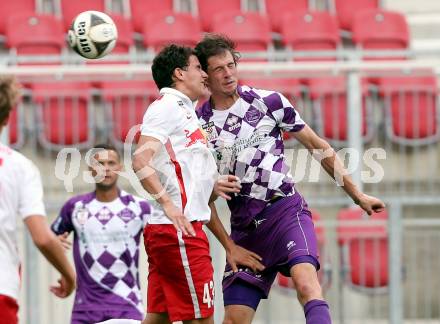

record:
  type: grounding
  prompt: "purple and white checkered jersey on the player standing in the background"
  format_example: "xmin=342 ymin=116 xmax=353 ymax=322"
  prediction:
xmin=52 ymin=191 xmax=151 ymax=320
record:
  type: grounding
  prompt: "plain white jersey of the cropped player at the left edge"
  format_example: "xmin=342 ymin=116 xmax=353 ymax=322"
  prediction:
xmin=0 ymin=143 xmax=46 ymax=299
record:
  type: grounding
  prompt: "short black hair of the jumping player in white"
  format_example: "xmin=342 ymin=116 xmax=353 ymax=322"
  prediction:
xmin=151 ymin=44 xmax=195 ymax=90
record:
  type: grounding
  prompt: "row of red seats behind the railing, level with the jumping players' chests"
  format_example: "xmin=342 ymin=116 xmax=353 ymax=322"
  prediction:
xmin=10 ymin=77 xmax=440 ymax=150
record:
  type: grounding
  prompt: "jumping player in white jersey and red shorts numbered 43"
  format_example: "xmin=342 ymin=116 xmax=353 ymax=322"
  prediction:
xmin=133 ymin=45 xmax=262 ymax=324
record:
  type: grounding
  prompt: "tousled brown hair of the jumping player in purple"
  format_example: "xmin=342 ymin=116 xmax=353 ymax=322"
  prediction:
xmin=195 ymin=33 xmax=240 ymax=72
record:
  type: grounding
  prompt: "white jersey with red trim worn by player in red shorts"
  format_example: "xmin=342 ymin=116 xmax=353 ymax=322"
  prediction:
xmin=141 ymin=88 xmax=217 ymax=224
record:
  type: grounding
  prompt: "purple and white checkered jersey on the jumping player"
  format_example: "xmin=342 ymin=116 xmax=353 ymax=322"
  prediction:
xmin=197 ymin=86 xmax=305 ymax=227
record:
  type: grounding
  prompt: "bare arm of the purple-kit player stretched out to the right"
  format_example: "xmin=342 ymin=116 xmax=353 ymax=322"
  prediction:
xmin=293 ymin=125 xmax=385 ymax=215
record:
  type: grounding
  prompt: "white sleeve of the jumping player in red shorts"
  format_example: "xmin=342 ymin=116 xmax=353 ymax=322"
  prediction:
xmin=141 ymin=99 xmax=178 ymax=144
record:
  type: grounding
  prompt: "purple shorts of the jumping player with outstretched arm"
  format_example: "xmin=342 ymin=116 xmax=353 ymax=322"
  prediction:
xmin=223 ymin=193 xmax=320 ymax=308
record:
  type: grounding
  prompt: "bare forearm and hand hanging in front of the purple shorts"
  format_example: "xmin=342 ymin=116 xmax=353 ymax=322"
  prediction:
xmin=206 ymin=202 xmax=264 ymax=272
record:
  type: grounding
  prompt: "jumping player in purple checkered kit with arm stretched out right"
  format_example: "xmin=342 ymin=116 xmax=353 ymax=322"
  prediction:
xmin=195 ymin=34 xmax=385 ymax=324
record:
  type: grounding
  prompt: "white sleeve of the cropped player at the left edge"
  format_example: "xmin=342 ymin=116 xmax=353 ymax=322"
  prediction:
xmin=18 ymin=159 xmax=46 ymax=219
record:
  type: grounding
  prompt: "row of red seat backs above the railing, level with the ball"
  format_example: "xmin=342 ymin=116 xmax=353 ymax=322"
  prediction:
xmin=0 ymin=1 xmax=409 ymax=63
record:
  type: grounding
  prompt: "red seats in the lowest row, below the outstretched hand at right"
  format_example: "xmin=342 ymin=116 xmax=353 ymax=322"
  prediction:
xmin=277 ymin=208 xmax=389 ymax=293
